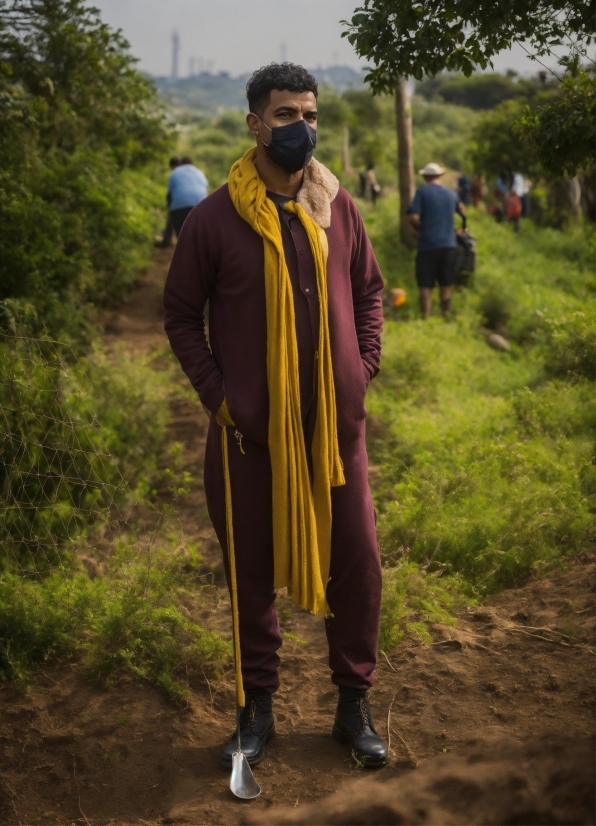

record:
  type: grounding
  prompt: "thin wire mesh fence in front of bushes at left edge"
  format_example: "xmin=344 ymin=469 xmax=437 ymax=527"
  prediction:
xmin=0 ymin=335 xmax=131 ymax=576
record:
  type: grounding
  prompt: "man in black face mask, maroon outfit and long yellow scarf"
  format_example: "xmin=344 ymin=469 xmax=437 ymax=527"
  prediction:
xmin=164 ymin=63 xmax=387 ymax=767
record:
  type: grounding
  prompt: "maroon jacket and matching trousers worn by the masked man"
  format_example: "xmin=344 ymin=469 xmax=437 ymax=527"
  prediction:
xmin=164 ymin=186 xmax=383 ymax=692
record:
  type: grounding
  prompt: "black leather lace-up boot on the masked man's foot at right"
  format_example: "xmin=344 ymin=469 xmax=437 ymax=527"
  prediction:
xmin=333 ymin=689 xmax=388 ymax=768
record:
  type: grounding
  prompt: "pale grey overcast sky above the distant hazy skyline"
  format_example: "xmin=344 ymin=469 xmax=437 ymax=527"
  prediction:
xmin=90 ymin=0 xmax=556 ymax=77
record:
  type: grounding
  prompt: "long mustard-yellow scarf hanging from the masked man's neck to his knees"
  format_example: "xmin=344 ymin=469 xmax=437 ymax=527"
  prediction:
xmin=226 ymin=148 xmax=345 ymax=616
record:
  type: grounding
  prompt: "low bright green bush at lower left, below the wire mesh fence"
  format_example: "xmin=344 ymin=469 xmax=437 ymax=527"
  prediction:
xmin=0 ymin=545 xmax=231 ymax=702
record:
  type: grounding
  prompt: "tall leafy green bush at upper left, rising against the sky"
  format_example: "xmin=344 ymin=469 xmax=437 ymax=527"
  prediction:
xmin=0 ymin=0 xmax=170 ymax=341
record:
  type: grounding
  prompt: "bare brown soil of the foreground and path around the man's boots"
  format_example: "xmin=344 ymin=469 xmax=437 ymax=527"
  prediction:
xmin=0 ymin=251 xmax=595 ymax=826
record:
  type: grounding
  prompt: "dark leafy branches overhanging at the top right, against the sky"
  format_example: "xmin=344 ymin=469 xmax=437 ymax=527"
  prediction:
xmin=342 ymin=0 xmax=594 ymax=93
